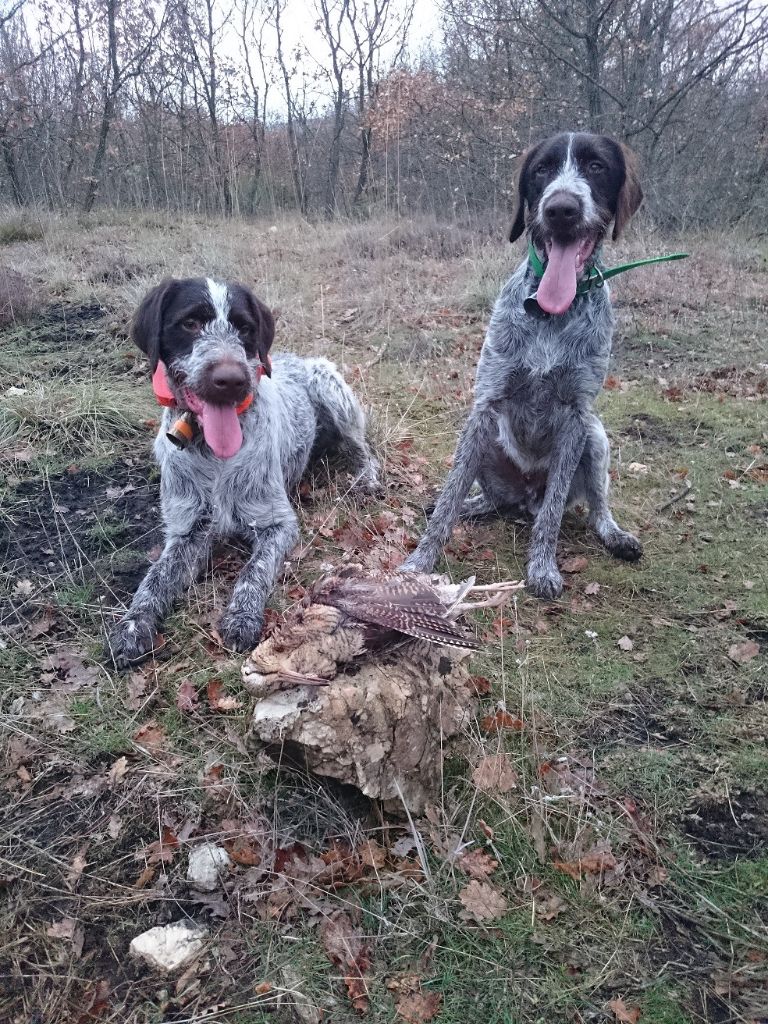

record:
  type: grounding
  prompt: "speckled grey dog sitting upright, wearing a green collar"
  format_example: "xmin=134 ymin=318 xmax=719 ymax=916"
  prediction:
xmin=402 ymin=133 xmax=642 ymax=598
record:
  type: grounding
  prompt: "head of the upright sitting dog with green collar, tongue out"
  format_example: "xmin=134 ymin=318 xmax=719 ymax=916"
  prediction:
xmin=510 ymin=132 xmax=643 ymax=313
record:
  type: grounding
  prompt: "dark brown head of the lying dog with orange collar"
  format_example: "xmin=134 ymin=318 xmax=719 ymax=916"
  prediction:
xmin=131 ymin=278 xmax=274 ymax=458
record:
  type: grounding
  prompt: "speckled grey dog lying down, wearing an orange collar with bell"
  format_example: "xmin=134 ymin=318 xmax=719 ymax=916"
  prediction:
xmin=109 ymin=279 xmax=378 ymax=666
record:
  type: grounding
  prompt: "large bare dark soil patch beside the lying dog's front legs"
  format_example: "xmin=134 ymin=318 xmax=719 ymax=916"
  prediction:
xmin=0 ymin=460 xmax=162 ymax=598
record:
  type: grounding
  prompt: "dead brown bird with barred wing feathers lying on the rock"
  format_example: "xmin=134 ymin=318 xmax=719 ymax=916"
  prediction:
xmin=243 ymin=565 xmax=523 ymax=692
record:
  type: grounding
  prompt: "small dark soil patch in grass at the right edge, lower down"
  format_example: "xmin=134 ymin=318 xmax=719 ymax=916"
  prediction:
xmin=685 ymin=791 xmax=768 ymax=860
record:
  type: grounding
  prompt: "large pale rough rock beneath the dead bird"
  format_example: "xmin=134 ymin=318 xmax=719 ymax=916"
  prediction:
xmin=243 ymin=640 xmax=476 ymax=814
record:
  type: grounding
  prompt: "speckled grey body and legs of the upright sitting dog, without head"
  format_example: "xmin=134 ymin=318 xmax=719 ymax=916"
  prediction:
xmin=402 ymin=260 xmax=642 ymax=597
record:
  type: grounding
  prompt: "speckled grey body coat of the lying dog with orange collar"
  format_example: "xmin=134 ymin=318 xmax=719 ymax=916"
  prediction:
xmin=109 ymin=352 xmax=378 ymax=665
